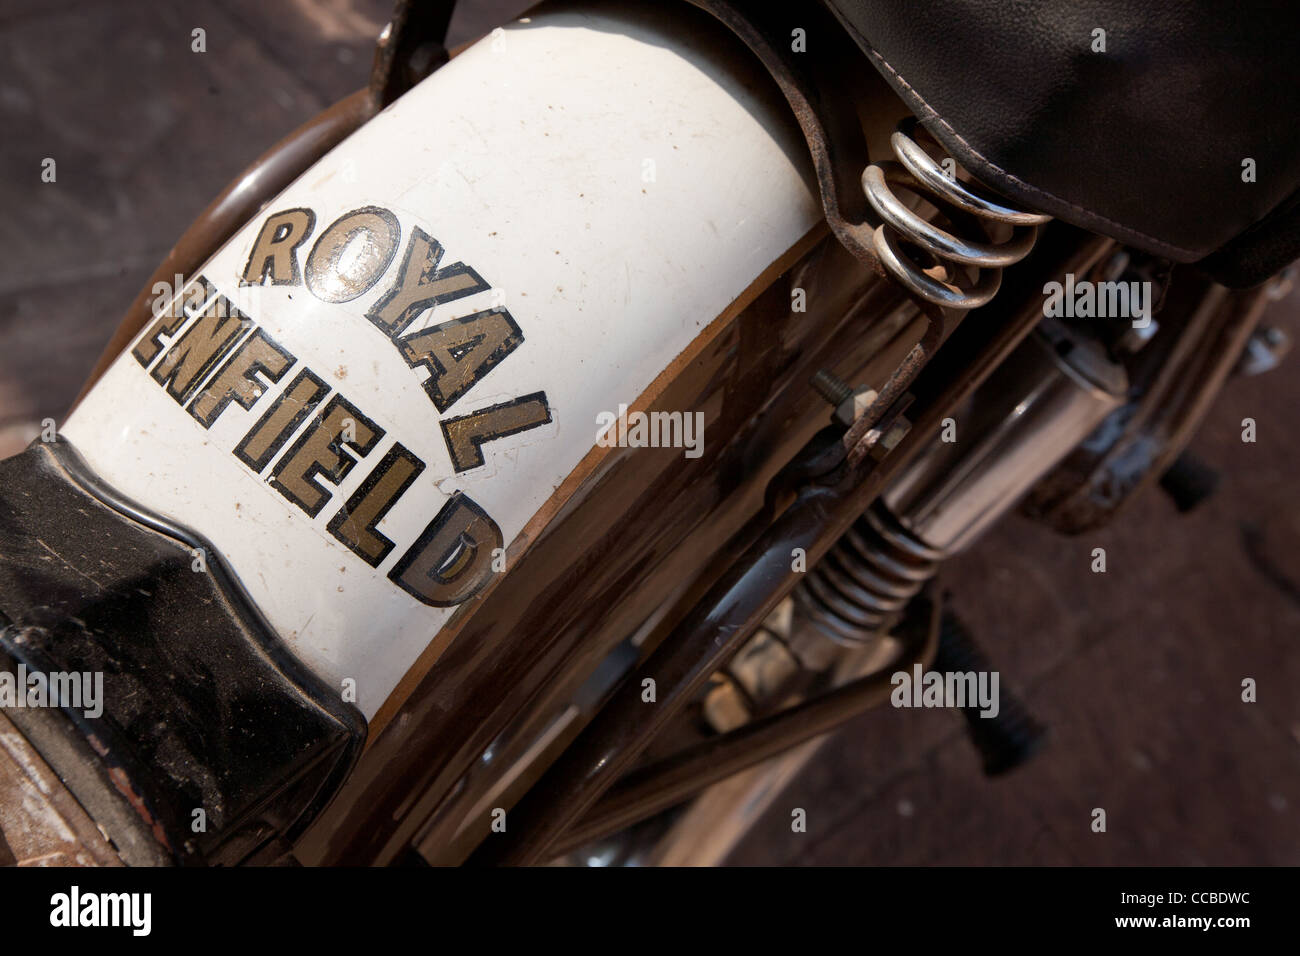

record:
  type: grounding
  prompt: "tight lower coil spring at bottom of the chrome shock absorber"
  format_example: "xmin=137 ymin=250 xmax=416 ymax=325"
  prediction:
xmin=794 ymin=502 xmax=945 ymax=644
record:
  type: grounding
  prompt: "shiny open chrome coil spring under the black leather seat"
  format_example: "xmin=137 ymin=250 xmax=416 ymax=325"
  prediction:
xmin=862 ymin=117 xmax=1052 ymax=310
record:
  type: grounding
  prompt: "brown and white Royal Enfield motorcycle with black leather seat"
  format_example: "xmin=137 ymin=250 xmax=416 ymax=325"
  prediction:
xmin=0 ymin=0 xmax=1300 ymax=865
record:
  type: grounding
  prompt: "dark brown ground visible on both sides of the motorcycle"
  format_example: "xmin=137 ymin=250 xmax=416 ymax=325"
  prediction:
xmin=0 ymin=0 xmax=1300 ymax=864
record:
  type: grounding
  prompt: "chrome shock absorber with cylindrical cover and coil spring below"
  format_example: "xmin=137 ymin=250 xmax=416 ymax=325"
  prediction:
xmin=794 ymin=319 xmax=1128 ymax=643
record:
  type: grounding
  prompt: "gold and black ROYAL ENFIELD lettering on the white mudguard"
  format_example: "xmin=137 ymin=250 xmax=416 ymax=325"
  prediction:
xmin=131 ymin=206 xmax=551 ymax=607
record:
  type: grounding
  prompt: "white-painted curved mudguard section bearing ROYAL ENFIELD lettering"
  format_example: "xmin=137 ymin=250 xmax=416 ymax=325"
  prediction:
xmin=62 ymin=4 xmax=820 ymax=718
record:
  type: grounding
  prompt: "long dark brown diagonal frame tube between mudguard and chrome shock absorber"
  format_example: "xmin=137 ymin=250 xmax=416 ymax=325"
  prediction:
xmin=476 ymin=229 xmax=1113 ymax=865
